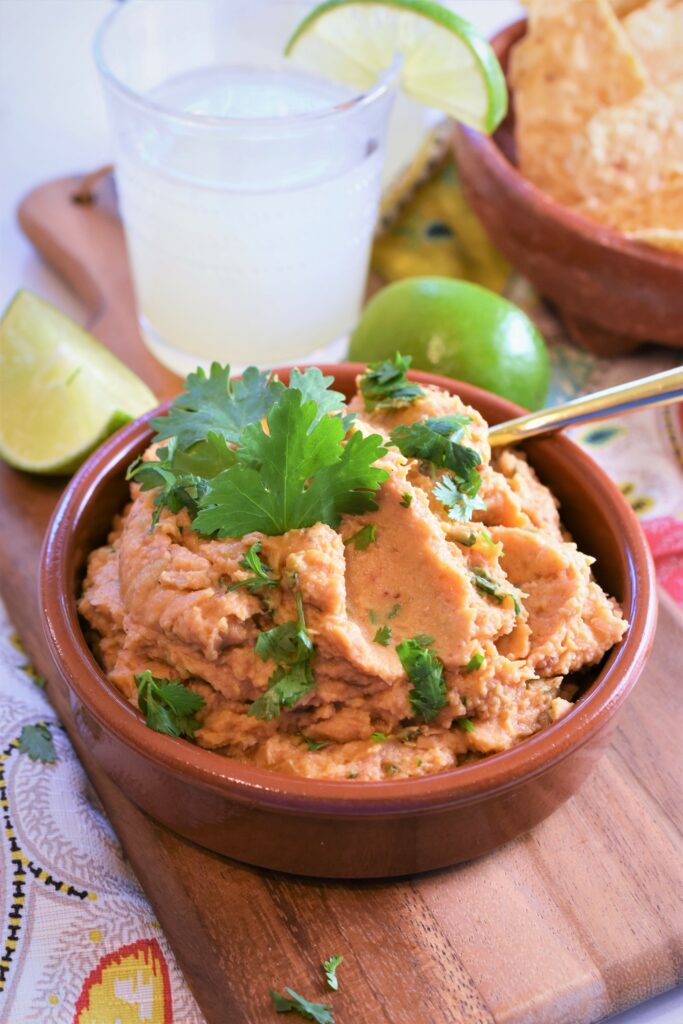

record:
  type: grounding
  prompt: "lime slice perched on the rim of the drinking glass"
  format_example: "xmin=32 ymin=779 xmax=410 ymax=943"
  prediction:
xmin=285 ymin=0 xmax=508 ymax=133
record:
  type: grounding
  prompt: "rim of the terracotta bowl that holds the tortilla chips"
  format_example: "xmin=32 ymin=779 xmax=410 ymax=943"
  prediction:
xmin=455 ymin=17 xmax=683 ymax=273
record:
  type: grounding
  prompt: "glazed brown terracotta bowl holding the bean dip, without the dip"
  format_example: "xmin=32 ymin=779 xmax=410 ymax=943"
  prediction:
xmin=41 ymin=364 xmax=656 ymax=878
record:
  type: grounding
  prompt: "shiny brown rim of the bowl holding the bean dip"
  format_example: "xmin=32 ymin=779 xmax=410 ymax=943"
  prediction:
xmin=40 ymin=364 xmax=656 ymax=816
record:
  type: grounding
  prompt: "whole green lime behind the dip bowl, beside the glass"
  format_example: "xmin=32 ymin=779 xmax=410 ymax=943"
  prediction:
xmin=348 ymin=278 xmax=550 ymax=409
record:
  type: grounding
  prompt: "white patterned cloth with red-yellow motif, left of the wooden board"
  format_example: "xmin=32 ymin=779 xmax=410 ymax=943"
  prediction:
xmin=0 ymin=603 xmax=204 ymax=1024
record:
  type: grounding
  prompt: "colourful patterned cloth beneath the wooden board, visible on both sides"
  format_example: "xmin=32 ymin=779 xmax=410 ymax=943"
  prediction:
xmin=0 ymin=146 xmax=683 ymax=1024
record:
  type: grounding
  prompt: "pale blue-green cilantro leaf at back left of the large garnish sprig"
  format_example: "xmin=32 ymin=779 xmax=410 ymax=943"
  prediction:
xmin=151 ymin=362 xmax=278 ymax=451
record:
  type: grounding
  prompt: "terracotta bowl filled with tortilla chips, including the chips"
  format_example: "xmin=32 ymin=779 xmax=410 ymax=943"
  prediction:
xmin=455 ymin=12 xmax=683 ymax=355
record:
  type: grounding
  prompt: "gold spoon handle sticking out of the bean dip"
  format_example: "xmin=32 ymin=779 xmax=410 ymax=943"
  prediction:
xmin=488 ymin=367 xmax=683 ymax=446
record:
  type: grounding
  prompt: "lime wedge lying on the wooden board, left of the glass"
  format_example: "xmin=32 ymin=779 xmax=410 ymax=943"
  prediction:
xmin=0 ymin=292 xmax=157 ymax=473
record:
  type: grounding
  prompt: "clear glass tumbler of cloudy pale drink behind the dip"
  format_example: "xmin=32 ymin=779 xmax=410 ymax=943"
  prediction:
xmin=95 ymin=0 xmax=395 ymax=374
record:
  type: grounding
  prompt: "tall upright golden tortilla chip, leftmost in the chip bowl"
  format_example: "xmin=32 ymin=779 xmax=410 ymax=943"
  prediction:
xmin=510 ymin=0 xmax=646 ymax=203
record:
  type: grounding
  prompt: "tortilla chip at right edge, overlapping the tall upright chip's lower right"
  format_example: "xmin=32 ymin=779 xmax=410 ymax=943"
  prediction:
xmin=568 ymin=79 xmax=683 ymax=209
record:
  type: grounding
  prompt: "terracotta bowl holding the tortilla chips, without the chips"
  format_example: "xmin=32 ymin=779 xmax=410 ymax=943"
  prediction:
xmin=454 ymin=19 xmax=683 ymax=355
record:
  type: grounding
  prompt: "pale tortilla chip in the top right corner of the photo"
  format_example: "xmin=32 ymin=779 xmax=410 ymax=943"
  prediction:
xmin=623 ymin=0 xmax=683 ymax=85
